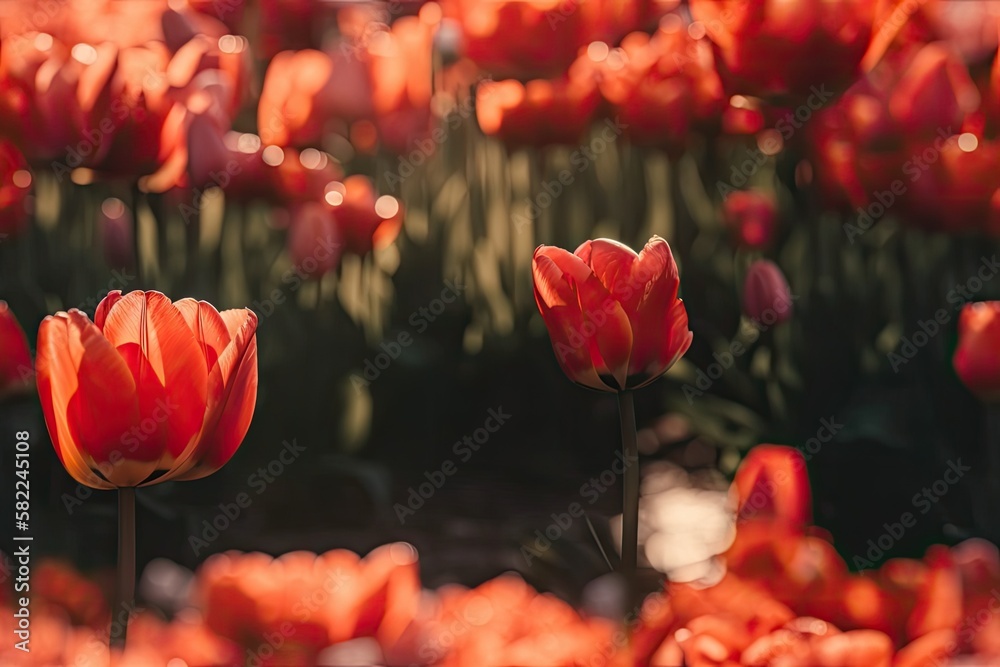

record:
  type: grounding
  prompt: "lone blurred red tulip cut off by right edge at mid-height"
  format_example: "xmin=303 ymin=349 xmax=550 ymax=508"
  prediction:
xmin=952 ymin=301 xmax=1000 ymax=403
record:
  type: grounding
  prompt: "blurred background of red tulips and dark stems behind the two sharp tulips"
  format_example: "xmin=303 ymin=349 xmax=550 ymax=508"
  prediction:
xmin=0 ymin=0 xmax=1000 ymax=616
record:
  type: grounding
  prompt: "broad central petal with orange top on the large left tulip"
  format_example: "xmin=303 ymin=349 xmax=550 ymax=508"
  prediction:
xmin=104 ymin=291 xmax=208 ymax=468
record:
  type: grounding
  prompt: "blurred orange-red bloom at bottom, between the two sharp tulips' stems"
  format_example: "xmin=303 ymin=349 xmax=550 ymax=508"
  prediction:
xmin=196 ymin=543 xmax=425 ymax=667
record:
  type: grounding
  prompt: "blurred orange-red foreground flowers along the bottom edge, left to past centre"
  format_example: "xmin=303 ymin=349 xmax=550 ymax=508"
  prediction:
xmin=0 ymin=544 xmax=628 ymax=667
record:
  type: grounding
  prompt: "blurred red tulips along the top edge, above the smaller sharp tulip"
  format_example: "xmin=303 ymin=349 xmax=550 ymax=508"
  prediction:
xmin=468 ymin=0 xmax=875 ymax=150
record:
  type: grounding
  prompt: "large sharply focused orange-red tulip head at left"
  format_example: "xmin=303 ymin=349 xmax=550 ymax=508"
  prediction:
xmin=37 ymin=291 xmax=257 ymax=489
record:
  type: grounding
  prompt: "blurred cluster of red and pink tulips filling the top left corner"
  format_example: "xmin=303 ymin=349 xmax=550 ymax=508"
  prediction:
xmin=0 ymin=0 xmax=410 ymax=275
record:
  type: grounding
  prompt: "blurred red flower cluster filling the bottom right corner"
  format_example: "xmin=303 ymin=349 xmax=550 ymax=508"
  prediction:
xmin=635 ymin=445 xmax=1000 ymax=667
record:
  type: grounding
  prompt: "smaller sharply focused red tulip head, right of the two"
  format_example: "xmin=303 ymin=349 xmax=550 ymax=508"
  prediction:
xmin=532 ymin=236 xmax=692 ymax=392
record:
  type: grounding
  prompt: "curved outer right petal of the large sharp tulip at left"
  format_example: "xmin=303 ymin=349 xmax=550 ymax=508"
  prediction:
xmin=168 ymin=309 xmax=257 ymax=480
